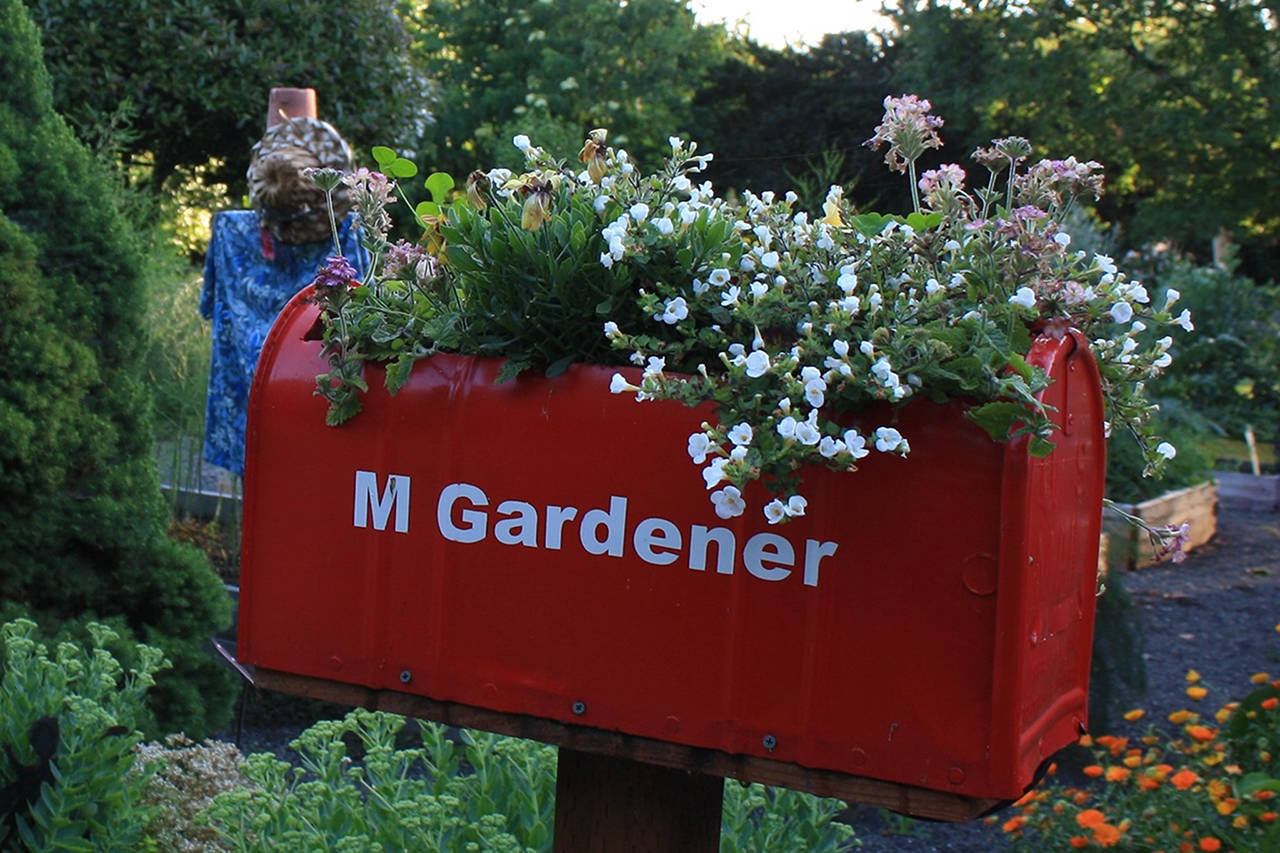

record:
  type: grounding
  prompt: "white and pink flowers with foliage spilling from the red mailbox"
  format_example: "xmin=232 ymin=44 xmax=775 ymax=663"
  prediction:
xmin=307 ymin=95 xmax=1192 ymax=523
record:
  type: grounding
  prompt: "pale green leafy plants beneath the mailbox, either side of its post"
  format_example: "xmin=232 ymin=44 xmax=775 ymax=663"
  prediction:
xmin=205 ymin=710 xmax=856 ymax=853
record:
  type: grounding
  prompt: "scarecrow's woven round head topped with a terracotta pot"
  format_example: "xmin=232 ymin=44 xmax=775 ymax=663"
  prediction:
xmin=248 ymin=88 xmax=356 ymax=246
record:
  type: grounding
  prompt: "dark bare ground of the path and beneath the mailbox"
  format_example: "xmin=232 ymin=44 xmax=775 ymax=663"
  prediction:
xmin=209 ymin=506 xmax=1280 ymax=853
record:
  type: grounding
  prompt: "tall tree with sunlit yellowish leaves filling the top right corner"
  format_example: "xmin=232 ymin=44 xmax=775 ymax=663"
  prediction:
xmin=893 ymin=0 xmax=1280 ymax=274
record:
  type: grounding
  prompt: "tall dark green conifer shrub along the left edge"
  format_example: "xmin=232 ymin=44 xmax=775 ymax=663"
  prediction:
xmin=0 ymin=0 xmax=234 ymax=734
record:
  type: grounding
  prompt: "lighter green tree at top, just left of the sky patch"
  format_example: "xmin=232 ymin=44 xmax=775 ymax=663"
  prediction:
xmin=412 ymin=0 xmax=724 ymax=177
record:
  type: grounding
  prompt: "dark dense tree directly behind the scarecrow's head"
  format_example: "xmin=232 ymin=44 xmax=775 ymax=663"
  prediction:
xmin=27 ymin=0 xmax=435 ymax=197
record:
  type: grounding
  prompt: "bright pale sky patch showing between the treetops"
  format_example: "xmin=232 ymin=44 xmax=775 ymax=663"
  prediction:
xmin=689 ymin=0 xmax=884 ymax=47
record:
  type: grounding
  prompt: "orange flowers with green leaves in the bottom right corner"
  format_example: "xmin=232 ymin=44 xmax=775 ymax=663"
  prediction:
xmin=988 ymin=670 xmax=1280 ymax=853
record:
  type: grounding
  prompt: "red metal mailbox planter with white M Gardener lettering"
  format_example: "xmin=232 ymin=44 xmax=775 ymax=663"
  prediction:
xmin=238 ymin=284 xmax=1105 ymax=811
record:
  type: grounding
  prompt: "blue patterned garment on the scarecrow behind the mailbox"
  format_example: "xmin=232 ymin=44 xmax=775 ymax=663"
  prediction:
xmin=200 ymin=210 xmax=367 ymax=476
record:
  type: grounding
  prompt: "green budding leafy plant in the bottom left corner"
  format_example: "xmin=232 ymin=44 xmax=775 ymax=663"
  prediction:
xmin=0 ymin=620 xmax=165 ymax=852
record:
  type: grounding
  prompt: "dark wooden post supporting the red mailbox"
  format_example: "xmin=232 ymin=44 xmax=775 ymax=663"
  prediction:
xmin=553 ymin=747 xmax=724 ymax=853
